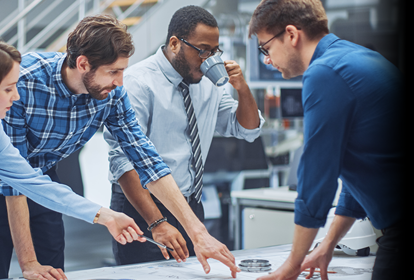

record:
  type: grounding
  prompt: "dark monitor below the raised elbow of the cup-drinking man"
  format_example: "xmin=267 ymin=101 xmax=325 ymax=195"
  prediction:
xmin=204 ymin=136 xmax=268 ymax=173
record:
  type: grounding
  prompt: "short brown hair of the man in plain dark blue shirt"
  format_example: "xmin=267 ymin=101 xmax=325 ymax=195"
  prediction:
xmin=249 ymin=0 xmax=329 ymax=40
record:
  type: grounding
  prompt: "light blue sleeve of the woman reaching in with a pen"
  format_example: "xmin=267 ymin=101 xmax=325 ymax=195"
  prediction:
xmin=0 ymin=122 xmax=101 ymax=223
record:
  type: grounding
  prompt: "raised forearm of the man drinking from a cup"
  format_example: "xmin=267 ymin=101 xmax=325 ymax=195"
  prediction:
xmin=236 ymin=84 xmax=260 ymax=129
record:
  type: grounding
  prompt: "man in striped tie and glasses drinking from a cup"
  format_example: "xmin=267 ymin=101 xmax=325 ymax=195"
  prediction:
xmin=104 ymin=6 xmax=264 ymax=264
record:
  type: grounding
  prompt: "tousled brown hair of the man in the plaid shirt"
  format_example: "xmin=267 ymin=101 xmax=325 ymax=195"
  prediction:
xmin=66 ymin=15 xmax=135 ymax=69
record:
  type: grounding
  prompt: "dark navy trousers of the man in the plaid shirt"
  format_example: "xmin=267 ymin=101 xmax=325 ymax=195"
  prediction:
xmin=0 ymin=169 xmax=65 ymax=279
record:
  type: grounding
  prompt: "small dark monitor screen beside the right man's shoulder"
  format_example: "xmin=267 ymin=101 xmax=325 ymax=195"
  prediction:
xmin=280 ymin=88 xmax=303 ymax=119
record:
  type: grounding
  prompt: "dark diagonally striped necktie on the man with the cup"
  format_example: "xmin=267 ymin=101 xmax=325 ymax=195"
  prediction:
xmin=179 ymin=81 xmax=204 ymax=202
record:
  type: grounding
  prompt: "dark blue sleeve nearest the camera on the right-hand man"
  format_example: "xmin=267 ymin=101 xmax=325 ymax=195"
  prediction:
xmin=295 ymin=64 xmax=356 ymax=228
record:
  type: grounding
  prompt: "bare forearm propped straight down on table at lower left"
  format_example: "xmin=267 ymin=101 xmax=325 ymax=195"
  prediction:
xmin=6 ymin=195 xmax=37 ymax=270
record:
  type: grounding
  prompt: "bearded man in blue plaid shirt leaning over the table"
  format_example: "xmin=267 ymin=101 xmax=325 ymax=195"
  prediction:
xmin=0 ymin=16 xmax=239 ymax=279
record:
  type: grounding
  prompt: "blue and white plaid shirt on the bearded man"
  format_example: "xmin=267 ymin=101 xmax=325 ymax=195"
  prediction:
xmin=0 ymin=53 xmax=170 ymax=195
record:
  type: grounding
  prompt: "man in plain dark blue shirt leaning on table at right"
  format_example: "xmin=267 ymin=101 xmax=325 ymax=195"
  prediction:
xmin=249 ymin=0 xmax=404 ymax=279
